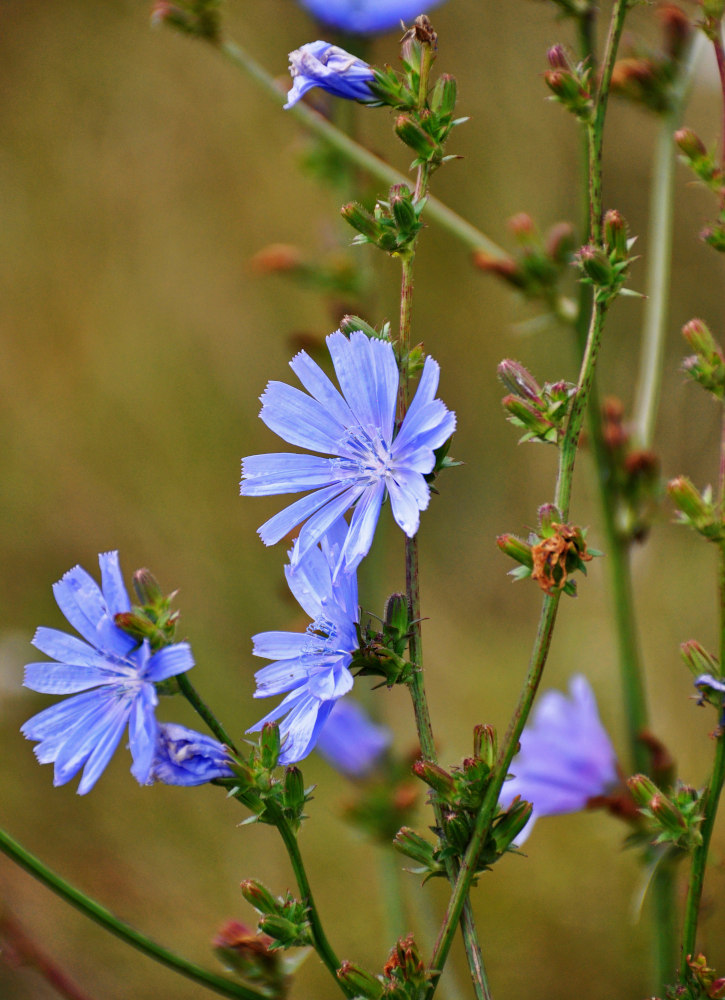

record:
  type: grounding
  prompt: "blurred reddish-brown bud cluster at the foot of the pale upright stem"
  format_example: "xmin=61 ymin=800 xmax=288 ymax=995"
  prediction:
xmin=602 ymin=397 xmax=662 ymax=542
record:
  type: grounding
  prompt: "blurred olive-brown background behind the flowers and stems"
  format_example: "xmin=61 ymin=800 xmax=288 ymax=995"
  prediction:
xmin=0 ymin=0 xmax=725 ymax=1000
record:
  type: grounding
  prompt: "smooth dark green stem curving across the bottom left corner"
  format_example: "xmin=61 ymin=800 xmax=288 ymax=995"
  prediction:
xmin=0 ymin=830 xmax=263 ymax=1000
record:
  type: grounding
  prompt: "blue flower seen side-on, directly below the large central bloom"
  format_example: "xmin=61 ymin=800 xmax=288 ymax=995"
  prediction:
xmin=249 ymin=521 xmax=359 ymax=764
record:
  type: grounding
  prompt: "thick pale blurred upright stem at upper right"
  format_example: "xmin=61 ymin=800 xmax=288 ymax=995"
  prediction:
xmin=633 ymin=32 xmax=706 ymax=449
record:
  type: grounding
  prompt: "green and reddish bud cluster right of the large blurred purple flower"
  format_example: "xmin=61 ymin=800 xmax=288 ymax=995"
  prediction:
xmin=627 ymin=774 xmax=704 ymax=852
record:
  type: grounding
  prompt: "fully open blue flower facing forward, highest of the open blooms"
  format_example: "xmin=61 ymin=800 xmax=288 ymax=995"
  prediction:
xmin=241 ymin=330 xmax=456 ymax=572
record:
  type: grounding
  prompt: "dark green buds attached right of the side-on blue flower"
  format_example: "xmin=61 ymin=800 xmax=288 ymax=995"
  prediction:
xmin=350 ymin=594 xmax=413 ymax=687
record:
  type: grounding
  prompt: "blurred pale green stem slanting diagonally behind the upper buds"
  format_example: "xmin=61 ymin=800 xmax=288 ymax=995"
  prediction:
xmin=218 ymin=38 xmax=508 ymax=260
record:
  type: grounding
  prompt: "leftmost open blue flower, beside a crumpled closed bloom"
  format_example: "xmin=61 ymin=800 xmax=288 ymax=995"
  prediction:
xmin=21 ymin=552 xmax=194 ymax=795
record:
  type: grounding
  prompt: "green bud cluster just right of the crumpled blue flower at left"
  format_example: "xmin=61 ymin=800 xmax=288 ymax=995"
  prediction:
xmin=228 ymin=722 xmax=314 ymax=830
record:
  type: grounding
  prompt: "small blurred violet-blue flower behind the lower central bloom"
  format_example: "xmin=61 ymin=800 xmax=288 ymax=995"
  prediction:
xmin=317 ymin=698 xmax=393 ymax=778
